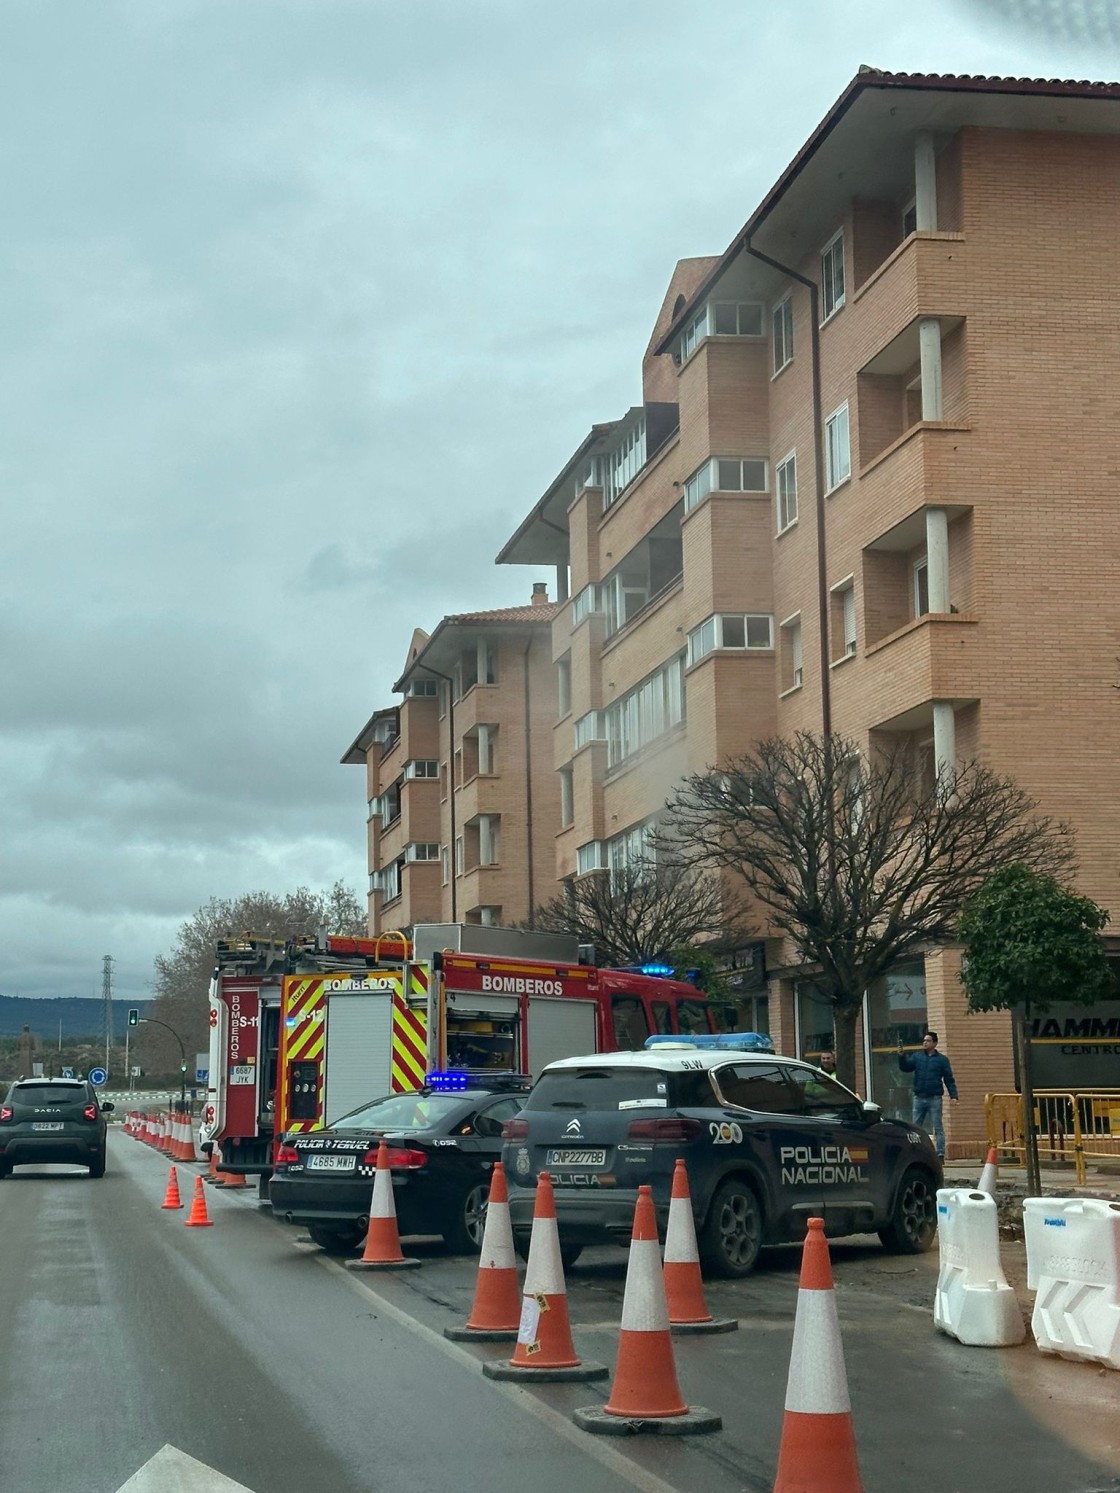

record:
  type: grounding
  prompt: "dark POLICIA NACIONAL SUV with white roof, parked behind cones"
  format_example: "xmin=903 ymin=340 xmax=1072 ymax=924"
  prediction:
xmin=503 ymin=1033 xmax=942 ymax=1277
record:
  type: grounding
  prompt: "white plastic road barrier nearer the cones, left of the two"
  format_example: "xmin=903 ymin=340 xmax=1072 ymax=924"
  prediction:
xmin=933 ymin=1187 xmax=1026 ymax=1348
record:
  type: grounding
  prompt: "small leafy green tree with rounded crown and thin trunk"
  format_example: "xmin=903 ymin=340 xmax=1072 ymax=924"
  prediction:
xmin=959 ymin=866 xmax=1113 ymax=1194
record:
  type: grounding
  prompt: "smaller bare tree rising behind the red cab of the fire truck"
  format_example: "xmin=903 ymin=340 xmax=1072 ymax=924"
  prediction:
xmin=533 ymin=860 xmax=747 ymax=966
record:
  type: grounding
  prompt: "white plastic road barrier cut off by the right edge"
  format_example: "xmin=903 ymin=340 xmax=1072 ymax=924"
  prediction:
xmin=1023 ymin=1197 xmax=1120 ymax=1369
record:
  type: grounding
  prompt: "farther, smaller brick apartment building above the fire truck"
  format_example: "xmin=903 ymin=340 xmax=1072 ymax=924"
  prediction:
xmin=342 ymin=584 xmax=560 ymax=935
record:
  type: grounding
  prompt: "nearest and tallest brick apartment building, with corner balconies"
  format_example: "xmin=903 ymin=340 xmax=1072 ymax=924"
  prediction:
xmin=499 ymin=70 xmax=1120 ymax=1154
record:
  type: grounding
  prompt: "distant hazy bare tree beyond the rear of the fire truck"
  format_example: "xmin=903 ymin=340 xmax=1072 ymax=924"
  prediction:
xmin=137 ymin=881 xmax=366 ymax=1072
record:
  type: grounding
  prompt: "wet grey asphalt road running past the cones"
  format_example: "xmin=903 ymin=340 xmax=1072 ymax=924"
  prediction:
xmin=0 ymin=1133 xmax=1120 ymax=1493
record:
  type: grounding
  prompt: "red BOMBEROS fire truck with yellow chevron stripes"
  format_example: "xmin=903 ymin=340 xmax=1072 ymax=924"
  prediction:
xmin=203 ymin=924 xmax=715 ymax=1176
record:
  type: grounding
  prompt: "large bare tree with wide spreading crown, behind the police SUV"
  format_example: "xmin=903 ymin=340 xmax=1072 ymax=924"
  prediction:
xmin=665 ymin=732 xmax=1072 ymax=1084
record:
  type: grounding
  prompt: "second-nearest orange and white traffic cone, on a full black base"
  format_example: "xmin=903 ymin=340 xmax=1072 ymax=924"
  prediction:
xmin=572 ymin=1185 xmax=723 ymax=1436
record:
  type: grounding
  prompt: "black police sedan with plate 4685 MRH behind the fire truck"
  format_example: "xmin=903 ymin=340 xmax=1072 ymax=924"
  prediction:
xmin=269 ymin=1073 xmax=530 ymax=1254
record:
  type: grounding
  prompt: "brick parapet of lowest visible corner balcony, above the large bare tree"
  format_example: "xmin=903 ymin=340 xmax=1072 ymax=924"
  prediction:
xmin=865 ymin=612 xmax=984 ymax=730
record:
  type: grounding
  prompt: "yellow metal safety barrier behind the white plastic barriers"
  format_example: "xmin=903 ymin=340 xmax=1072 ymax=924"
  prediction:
xmin=984 ymin=1088 xmax=1120 ymax=1185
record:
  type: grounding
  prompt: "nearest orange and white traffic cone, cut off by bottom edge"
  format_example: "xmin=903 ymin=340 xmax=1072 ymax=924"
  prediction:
xmin=774 ymin=1218 xmax=863 ymax=1493
